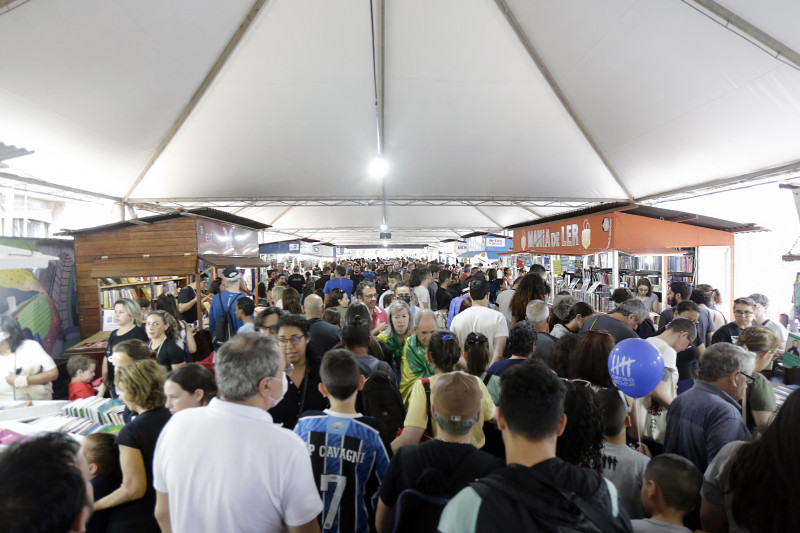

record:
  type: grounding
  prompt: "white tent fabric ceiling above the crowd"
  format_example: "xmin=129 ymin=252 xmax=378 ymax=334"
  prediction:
xmin=0 ymin=0 xmax=800 ymax=244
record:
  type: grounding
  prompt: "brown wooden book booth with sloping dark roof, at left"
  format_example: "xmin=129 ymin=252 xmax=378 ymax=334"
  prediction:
xmin=64 ymin=209 xmax=269 ymax=339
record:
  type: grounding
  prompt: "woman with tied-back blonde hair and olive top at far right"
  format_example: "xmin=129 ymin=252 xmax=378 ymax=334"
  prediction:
xmin=736 ymin=326 xmax=779 ymax=437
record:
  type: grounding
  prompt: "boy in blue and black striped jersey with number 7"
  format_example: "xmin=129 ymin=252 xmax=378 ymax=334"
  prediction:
xmin=294 ymin=349 xmax=390 ymax=533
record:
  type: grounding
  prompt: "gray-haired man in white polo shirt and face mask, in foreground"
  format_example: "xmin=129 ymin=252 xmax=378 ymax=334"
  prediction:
xmin=153 ymin=333 xmax=322 ymax=533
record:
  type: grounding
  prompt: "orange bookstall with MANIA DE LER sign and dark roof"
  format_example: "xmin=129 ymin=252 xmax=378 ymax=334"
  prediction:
xmin=508 ymin=204 xmax=759 ymax=312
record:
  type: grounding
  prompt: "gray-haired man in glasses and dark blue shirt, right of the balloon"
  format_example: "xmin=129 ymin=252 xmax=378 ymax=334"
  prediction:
xmin=664 ymin=342 xmax=755 ymax=472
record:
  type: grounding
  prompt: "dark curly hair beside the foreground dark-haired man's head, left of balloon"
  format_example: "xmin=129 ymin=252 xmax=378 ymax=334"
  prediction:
xmin=556 ymin=380 xmax=603 ymax=472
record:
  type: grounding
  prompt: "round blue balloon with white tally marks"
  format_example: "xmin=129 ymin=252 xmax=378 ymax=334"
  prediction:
xmin=608 ymin=339 xmax=664 ymax=398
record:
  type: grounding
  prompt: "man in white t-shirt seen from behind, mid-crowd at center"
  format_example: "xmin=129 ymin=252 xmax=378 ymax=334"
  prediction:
xmin=450 ymin=279 xmax=508 ymax=362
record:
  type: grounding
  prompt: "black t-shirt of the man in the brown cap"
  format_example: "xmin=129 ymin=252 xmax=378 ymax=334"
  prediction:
xmin=380 ymin=439 xmax=504 ymax=508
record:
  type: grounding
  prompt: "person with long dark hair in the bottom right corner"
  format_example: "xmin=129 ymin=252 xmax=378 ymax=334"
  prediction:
xmin=700 ymin=390 xmax=800 ymax=533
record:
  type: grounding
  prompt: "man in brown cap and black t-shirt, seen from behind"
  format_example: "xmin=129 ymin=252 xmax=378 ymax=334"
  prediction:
xmin=375 ymin=372 xmax=503 ymax=531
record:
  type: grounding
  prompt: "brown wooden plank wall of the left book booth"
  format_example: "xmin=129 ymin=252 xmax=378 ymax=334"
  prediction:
xmin=75 ymin=217 xmax=197 ymax=339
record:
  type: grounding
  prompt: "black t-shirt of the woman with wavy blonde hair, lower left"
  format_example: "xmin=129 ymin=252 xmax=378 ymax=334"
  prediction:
xmin=108 ymin=407 xmax=170 ymax=533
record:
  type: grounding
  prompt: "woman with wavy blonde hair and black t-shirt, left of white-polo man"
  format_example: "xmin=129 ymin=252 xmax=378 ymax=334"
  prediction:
xmin=94 ymin=358 xmax=170 ymax=533
